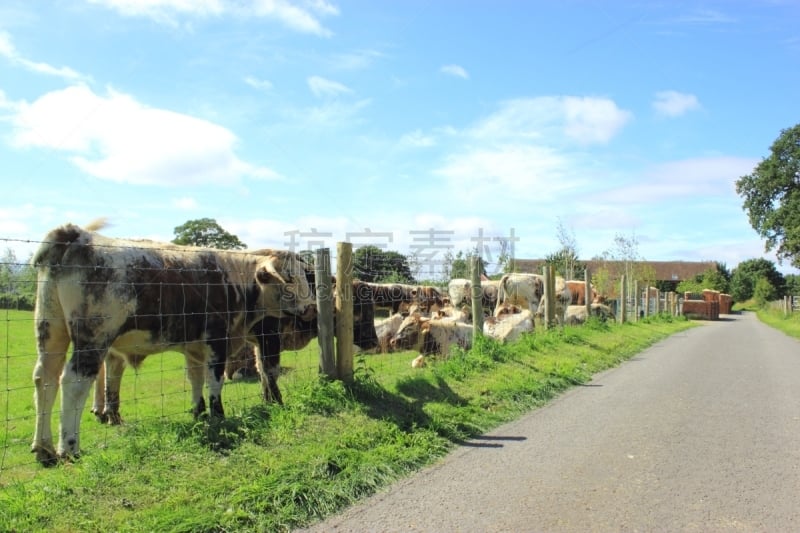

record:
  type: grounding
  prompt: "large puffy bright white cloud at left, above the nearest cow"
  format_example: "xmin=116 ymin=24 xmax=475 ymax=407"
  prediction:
xmin=7 ymin=85 xmax=277 ymax=185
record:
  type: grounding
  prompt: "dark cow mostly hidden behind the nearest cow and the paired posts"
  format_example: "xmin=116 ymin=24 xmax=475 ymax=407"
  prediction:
xmin=92 ymin=278 xmax=378 ymax=425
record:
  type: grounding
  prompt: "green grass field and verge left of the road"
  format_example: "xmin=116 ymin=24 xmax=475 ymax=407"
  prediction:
xmin=0 ymin=311 xmax=691 ymax=531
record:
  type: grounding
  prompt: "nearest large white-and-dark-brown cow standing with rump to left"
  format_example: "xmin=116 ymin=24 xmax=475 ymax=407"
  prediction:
xmin=31 ymin=223 xmax=316 ymax=466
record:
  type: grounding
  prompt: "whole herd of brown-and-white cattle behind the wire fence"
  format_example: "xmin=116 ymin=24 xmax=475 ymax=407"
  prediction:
xmin=26 ymin=222 xmax=610 ymax=465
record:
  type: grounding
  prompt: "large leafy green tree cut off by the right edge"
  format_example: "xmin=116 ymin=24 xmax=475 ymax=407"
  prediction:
xmin=736 ymin=124 xmax=800 ymax=267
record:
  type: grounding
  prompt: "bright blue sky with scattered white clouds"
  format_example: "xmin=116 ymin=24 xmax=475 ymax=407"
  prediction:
xmin=0 ymin=0 xmax=800 ymax=277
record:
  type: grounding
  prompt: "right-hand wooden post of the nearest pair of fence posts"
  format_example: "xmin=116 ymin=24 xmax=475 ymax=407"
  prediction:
xmin=336 ymin=242 xmax=353 ymax=381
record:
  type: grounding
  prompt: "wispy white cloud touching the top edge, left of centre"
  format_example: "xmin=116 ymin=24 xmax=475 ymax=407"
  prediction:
xmin=89 ymin=0 xmax=339 ymax=37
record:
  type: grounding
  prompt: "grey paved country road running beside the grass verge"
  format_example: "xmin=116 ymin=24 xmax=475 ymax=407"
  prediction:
xmin=298 ymin=314 xmax=800 ymax=532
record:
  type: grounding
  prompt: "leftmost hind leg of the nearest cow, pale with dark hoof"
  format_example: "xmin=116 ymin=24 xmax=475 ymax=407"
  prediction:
xmin=31 ymin=316 xmax=70 ymax=466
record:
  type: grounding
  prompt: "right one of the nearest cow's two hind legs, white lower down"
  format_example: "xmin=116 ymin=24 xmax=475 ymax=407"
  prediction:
xmin=57 ymin=339 xmax=108 ymax=458
